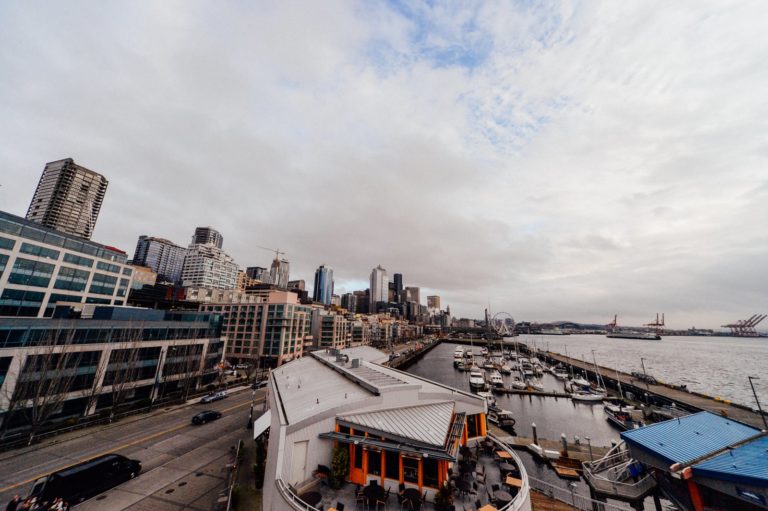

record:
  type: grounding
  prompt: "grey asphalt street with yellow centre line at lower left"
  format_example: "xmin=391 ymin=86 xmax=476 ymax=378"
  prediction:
xmin=0 ymin=389 xmax=264 ymax=511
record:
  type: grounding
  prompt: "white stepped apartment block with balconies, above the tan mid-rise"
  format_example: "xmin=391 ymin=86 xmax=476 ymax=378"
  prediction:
xmin=181 ymin=244 xmax=240 ymax=289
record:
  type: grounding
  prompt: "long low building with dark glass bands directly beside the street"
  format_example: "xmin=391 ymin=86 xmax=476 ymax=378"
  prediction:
xmin=0 ymin=304 xmax=224 ymax=431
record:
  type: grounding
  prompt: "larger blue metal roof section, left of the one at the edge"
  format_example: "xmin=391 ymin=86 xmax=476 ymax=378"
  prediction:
xmin=621 ymin=412 xmax=760 ymax=465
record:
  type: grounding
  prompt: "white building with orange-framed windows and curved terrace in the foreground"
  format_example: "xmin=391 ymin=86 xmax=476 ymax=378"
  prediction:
xmin=260 ymin=347 xmax=531 ymax=511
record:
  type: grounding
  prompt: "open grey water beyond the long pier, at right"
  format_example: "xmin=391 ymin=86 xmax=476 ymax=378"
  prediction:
xmin=515 ymin=335 xmax=768 ymax=408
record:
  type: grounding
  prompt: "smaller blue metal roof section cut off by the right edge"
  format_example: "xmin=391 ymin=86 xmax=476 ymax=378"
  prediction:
xmin=693 ymin=437 xmax=768 ymax=487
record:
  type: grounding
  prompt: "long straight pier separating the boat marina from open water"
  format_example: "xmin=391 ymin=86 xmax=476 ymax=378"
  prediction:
xmin=545 ymin=352 xmax=764 ymax=429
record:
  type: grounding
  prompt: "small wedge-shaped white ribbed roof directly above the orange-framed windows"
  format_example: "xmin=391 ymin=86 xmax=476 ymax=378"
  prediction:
xmin=339 ymin=401 xmax=454 ymax=447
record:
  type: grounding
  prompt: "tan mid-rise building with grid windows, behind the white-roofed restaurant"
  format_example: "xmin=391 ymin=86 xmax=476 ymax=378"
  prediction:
xmin=200 ymin=289 xmax=312 ymax=368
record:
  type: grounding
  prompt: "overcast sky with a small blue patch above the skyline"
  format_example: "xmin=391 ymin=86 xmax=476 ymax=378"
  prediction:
xmin=0 ymin=0 xmax=768 ymax=328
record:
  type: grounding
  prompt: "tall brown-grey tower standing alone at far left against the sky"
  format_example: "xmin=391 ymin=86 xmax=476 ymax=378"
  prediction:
xmin=27 ymin=158 xmax=109 ymax=240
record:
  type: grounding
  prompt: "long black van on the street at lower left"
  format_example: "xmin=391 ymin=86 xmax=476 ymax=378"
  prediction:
xmin=29 ymin=454 xmax=141 ymax=505
